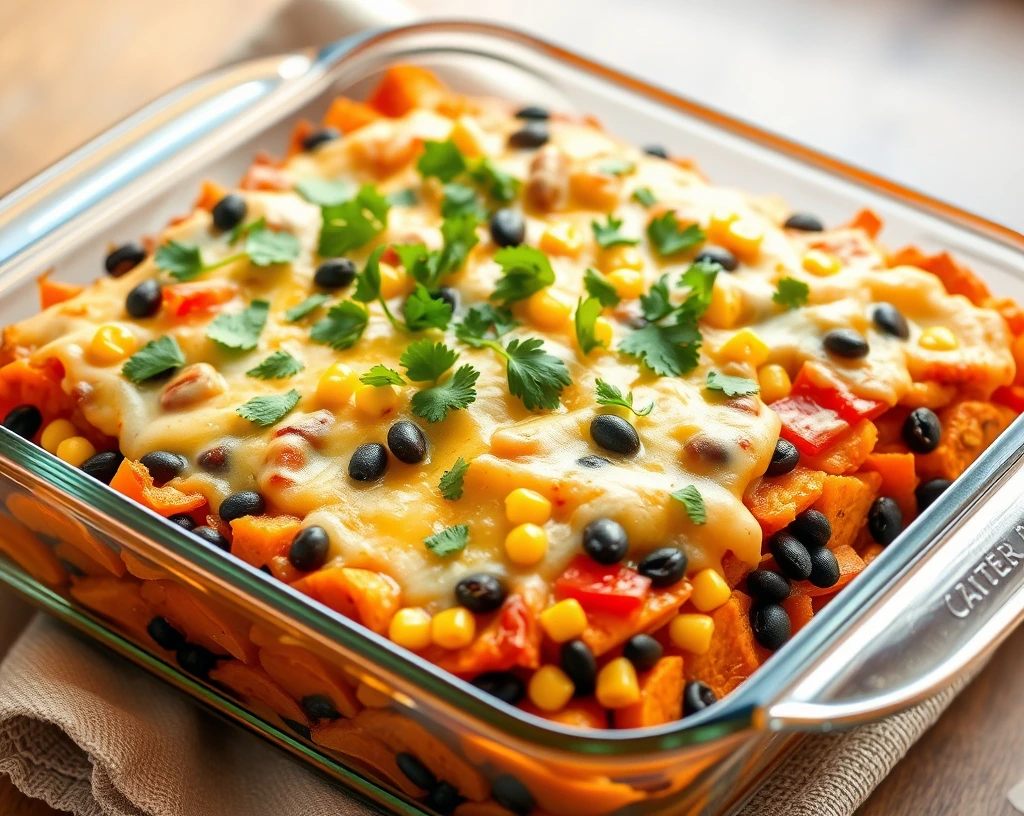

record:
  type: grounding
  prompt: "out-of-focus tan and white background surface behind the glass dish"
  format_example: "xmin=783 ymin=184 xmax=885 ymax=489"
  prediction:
xmin=0 ymin=0 xmax=1024 ymax=230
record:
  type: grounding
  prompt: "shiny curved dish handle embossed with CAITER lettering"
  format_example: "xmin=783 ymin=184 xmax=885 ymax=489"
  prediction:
xmin=756 ymin=421 xmax=1024 ymax=731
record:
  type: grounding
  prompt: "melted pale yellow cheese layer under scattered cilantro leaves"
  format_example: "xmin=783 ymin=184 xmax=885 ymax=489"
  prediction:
xmin=8 ymin=106 xmax=1014 ymax=609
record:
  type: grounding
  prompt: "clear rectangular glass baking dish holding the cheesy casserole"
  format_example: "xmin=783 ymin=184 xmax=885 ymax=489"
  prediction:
xmin=0 ymin=23 xmax=1024 ymax=816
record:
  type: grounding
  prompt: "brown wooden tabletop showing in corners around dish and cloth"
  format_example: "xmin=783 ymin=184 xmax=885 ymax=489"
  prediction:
xmin=0 ymin=0 xmax=1024 ymax=816
